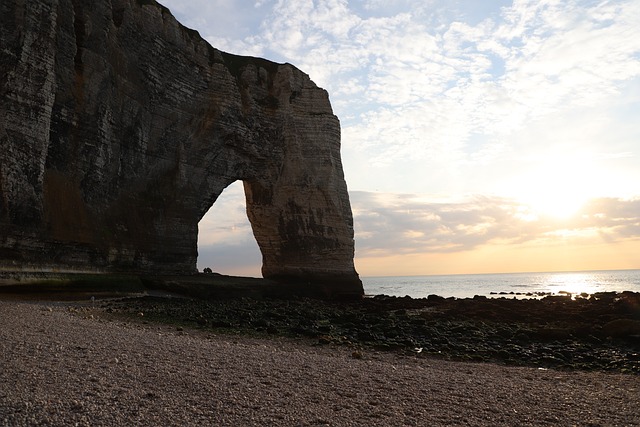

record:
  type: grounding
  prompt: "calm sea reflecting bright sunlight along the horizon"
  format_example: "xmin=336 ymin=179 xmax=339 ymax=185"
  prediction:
xmin=361 ymin=270 xmax=640 ymax=298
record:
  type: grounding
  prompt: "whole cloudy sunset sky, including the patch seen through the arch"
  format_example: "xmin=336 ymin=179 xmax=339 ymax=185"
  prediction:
xmin=160 ymin=0 xmax=640 ymax=277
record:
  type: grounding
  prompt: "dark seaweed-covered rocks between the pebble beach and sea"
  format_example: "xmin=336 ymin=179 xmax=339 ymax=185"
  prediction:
xmin=91 ymin=292 xmax=640 ymax=374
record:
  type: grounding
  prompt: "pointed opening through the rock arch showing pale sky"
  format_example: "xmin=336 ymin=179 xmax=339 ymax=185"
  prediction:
xmin=197 ymin=180 xmax=262 ymax=277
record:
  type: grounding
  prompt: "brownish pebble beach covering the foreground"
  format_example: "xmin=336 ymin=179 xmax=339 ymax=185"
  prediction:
xmin=0 ymin=301 xmax=640 ymax=426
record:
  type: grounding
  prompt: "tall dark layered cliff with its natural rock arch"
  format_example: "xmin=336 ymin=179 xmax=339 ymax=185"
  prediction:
xmin=0 ymin=0 xmax=362 ymax=293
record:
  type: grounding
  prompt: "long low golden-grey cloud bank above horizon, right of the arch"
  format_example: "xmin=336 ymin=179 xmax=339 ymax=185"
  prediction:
xmin=351 ymin=191 xmax=640 ymax=257
